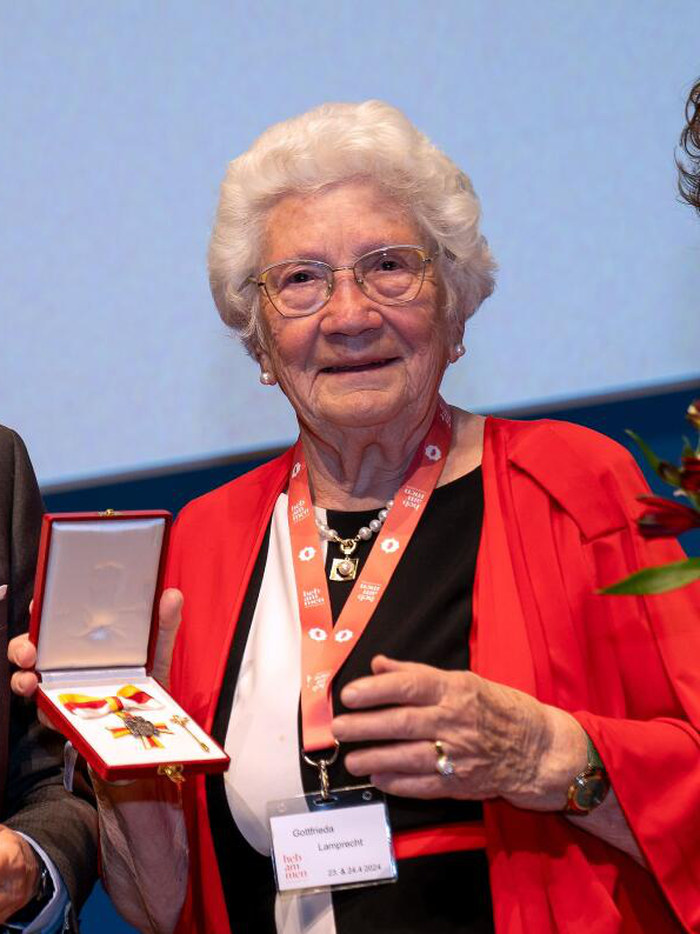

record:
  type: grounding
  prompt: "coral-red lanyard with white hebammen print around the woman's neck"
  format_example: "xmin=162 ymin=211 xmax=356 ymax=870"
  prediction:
xmin=288 ymin=399 xmax=452 ymax=753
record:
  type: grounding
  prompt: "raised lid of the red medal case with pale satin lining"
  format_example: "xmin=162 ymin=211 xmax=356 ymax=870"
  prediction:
xmin=29 ymin=510 xmax=172 ymax=673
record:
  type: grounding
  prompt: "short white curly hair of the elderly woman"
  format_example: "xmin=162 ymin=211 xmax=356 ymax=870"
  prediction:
xmin=209 ymin=100 xmax=496 ymax=355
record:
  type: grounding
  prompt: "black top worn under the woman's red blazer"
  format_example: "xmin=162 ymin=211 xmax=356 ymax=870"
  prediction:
xmin=207 ymin=468 xmax=493 ymax=934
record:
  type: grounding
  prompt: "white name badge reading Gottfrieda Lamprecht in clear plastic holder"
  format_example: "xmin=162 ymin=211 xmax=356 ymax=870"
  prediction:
xmin=267 ymin=785 xmax=398 ymax=895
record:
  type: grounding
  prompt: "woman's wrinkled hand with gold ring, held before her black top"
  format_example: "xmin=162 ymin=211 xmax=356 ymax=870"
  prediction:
xmin=333 ymin=655 xmax=587 ymax=811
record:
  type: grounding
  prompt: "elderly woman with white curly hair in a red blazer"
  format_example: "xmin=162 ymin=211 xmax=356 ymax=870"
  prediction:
xmin=12 ymin=101 xmax=700 ymax=934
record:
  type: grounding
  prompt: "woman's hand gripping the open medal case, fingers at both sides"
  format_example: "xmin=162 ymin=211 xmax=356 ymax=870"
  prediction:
xmin=7 ymin=587 xmax=184 ymax=697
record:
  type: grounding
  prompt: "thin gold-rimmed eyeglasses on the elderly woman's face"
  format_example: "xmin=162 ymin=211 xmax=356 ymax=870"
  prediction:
xmin=247 ymin=244 xmax=434 ymax=318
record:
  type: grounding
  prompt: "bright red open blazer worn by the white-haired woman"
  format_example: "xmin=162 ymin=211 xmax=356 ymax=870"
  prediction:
xmin=168 ymin=419 xmax=700 ymax=934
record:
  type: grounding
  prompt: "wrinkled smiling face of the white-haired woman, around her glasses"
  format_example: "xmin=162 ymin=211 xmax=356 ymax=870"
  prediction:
xmin=260 ymin=181 xmax=448 ymax=431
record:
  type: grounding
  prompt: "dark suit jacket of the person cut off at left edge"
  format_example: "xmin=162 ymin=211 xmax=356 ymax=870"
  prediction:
xmin=0 ymin=427 xmax=97 ymax=920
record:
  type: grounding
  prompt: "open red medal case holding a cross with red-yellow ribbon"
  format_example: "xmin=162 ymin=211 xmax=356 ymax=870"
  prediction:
xmin=29 ymin=510 xmax=229 ymax=781
